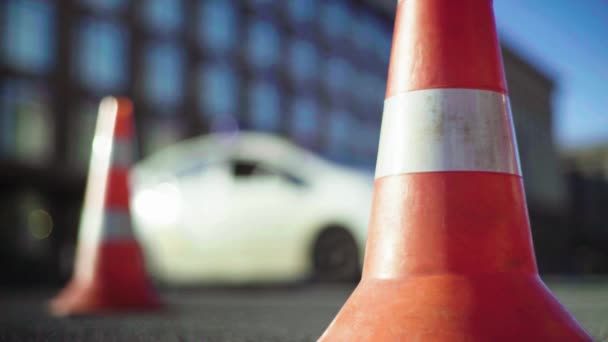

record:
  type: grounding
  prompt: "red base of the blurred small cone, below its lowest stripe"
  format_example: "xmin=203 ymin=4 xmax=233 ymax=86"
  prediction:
xmin=50 ymin=241 xmax=162 ymax=316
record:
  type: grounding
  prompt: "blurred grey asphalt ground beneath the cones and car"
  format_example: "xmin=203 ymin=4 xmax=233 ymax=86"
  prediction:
xmin=0 ymin=279 xmax=608 ymax=342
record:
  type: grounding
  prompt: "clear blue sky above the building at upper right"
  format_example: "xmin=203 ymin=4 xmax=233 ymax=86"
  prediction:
xmin=494 ymin=0 xmax=608 ymax=150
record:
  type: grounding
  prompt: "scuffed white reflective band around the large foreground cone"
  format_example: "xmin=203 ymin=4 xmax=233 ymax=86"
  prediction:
xmin=376 ymin=89 xmax=521 ymax=178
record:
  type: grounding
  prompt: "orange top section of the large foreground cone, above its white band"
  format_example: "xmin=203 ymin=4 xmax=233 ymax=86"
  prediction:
xmin=386 ymin=0 xmax=508 ymax=98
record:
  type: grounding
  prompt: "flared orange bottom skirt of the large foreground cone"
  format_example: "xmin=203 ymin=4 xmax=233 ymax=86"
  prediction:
xmin=319 ymin=273 xmax=591 ymax=342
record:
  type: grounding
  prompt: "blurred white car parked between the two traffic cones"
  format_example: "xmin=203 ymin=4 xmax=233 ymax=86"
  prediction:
xmin=131 ymin=132 xmax=373 ymax=285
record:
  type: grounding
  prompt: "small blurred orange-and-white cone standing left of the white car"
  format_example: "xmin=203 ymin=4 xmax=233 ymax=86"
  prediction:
xmin=51 ymin=97 xmax=160 ymax=315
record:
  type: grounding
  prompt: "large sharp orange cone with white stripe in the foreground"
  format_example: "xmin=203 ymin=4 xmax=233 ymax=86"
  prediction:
xmin=320 ymin=0 xmax=590 ymax=341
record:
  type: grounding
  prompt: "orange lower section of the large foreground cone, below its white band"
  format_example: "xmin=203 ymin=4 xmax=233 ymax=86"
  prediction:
xmin=321 ymin=172 xmax=591 ymax=341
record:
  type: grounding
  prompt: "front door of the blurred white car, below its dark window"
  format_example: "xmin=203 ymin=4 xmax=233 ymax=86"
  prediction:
xmin=223 ymin=158 xmax=307 ymax=272
